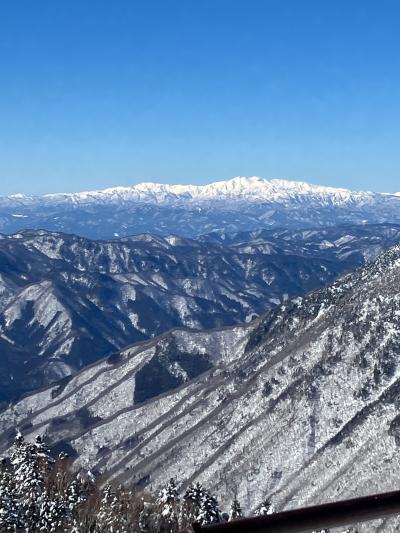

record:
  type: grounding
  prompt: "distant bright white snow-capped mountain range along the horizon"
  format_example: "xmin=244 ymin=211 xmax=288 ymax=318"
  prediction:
xmin=0 ymin=177 xmax=400 ymax=239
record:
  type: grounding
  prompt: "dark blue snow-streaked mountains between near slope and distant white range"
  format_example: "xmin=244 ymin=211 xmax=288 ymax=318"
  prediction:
xmin=0 ymin=224 xmax=400 ymax=400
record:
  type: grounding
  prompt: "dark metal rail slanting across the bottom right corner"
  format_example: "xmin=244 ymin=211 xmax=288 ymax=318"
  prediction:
xmin=182 ymin=491 xmax=400 ymax=533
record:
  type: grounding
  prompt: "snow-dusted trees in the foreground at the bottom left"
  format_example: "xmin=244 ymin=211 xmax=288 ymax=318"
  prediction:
xmin=0 ymin=433 xmax=272 ymax=533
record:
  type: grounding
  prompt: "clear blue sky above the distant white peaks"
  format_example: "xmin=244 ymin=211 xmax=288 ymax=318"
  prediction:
xmin=0 ymin=0 xmax=400 ymax=194
